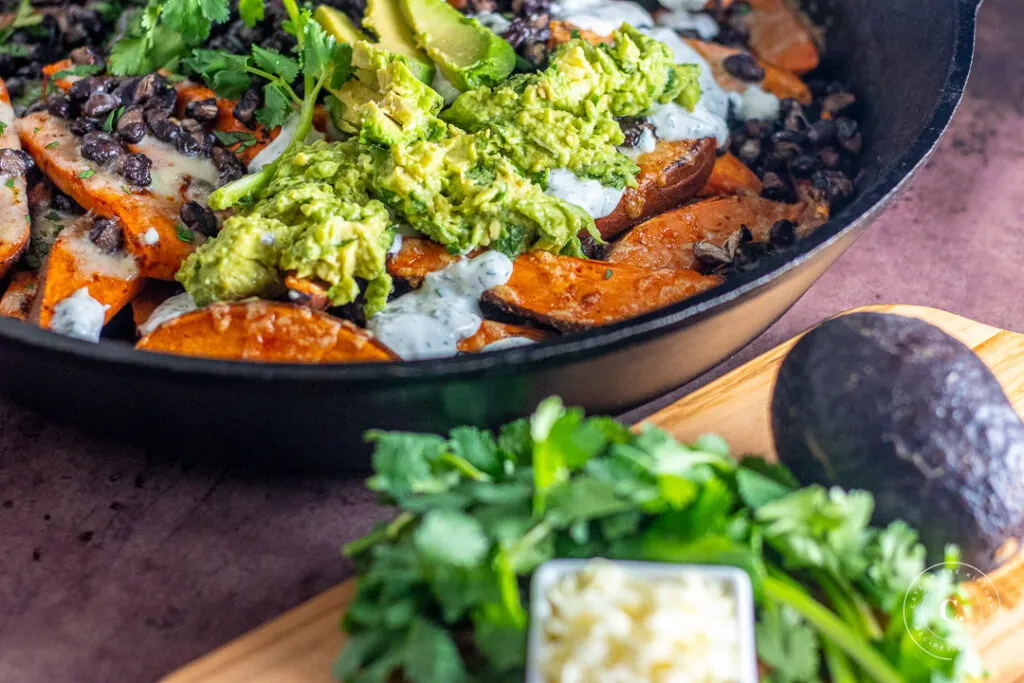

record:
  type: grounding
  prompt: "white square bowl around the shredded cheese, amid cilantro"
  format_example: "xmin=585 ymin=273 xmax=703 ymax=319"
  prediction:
xmin=526 ymin=558 xmax=758 ymax=683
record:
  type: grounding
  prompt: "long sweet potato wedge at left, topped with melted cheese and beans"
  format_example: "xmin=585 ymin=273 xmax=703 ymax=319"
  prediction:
xmin=18 ymin=112 xmax=218 ymax=280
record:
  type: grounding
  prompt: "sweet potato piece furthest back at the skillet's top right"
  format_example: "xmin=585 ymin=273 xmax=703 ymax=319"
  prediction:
xmin=742 ymin=0 xmax=818 ymax=75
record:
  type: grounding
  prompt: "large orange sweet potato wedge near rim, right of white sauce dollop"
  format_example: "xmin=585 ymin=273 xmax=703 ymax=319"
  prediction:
xmin=483 ymin=251 xmax=723 ymax=332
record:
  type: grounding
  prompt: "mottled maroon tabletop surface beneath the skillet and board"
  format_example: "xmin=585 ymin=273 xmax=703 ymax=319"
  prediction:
xmin=0 ymin=0 xmax=1024 ymax=683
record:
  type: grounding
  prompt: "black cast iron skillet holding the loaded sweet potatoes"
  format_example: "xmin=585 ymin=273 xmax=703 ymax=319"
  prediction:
xmin=0 ymin=0 xmax=980 ymax=469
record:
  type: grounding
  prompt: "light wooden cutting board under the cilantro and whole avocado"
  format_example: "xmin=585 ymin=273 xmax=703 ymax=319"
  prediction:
xmin=161 ymin=305 xmax=1024 ymax=683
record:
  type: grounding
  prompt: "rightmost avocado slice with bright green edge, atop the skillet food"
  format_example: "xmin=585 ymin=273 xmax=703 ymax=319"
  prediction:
xmin=397 ymin=0 xmax=515 ymax=92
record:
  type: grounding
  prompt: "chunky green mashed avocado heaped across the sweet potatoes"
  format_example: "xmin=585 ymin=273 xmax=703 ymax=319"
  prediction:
xmin=177 ymin=26 xmax=699 ymax=315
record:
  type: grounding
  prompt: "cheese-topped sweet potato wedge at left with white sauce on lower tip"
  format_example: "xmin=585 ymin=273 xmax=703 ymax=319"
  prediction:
xmin=29 ymin=214 xmax=143 ymax=329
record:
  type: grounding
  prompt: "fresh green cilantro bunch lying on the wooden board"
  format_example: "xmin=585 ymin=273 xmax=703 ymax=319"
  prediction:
xmin=335 ymin=398 xmax=978 ymax=683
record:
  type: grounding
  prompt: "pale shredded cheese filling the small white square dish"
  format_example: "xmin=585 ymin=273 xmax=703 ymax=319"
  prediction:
xmin=540 ymin=562 xmax=742 ymax=683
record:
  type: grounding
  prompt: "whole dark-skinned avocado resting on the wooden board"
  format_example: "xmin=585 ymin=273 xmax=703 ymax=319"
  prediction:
xmin=771 ymin=312 xmax=1024 ymax=571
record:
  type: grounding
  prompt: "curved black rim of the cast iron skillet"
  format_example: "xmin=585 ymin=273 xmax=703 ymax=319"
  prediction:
xmin=0 ymin=0 xmax=980 ymax=384
